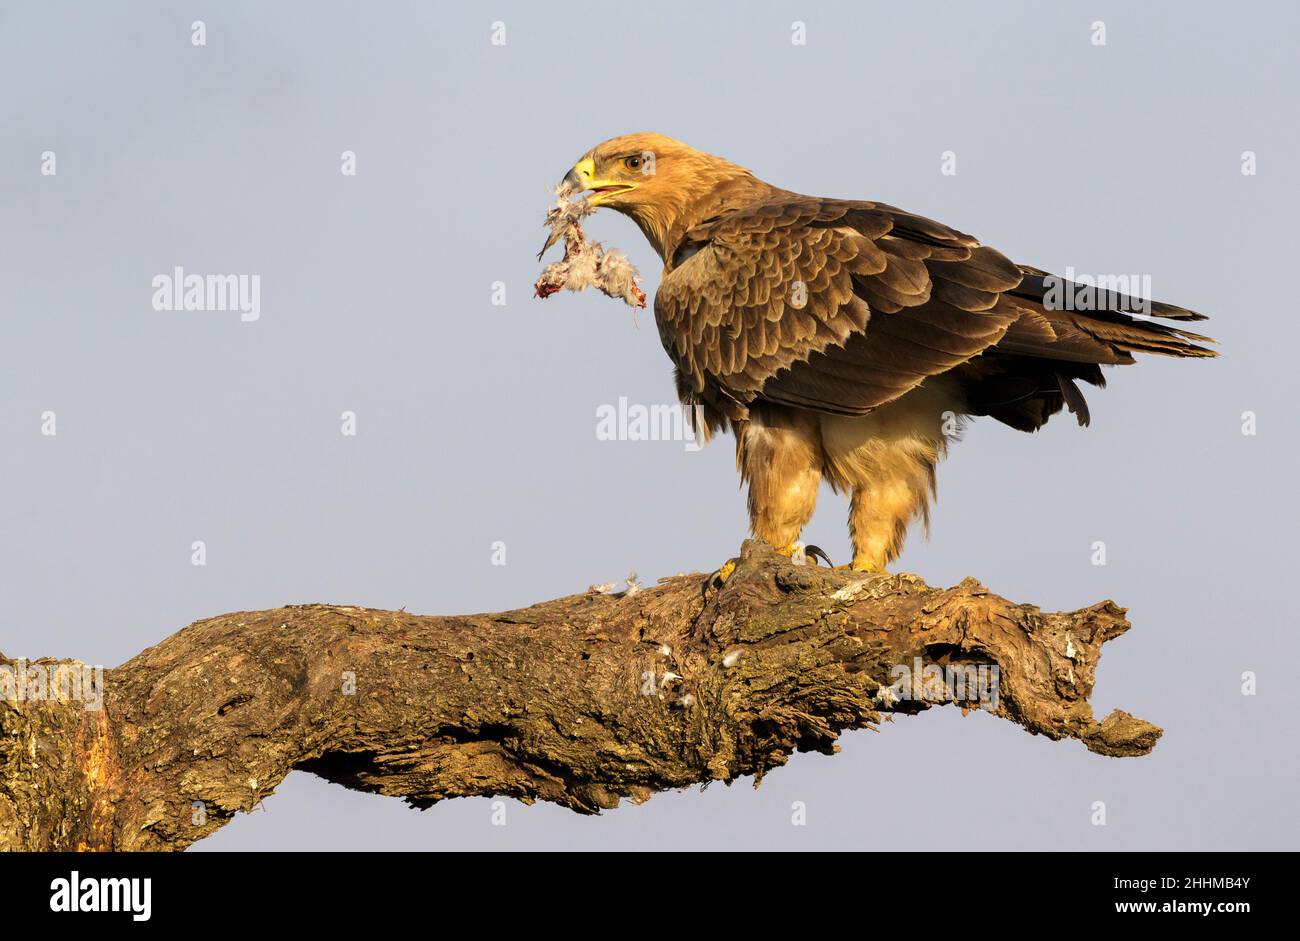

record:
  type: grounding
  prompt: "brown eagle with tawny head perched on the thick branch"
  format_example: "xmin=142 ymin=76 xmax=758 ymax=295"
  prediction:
xmin=562 ymin=134 xmax=1216 ymax=576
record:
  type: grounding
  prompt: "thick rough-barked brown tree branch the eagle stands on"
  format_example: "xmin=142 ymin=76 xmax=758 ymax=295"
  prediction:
xmin=0 ymin=542 xmax=1161 ymax=850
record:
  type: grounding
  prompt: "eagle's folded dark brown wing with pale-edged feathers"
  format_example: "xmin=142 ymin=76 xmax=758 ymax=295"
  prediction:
xmin=655 ymin=194 xmax=1213 ymax=426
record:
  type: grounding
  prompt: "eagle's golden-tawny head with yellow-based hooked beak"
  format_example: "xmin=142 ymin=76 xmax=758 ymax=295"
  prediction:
xmin=563 ymin=133 xmax=770 ymax=256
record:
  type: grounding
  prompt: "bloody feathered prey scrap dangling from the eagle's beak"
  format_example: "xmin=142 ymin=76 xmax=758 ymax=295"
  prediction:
xmin=533 ymin=183 xmax=646 ymax=307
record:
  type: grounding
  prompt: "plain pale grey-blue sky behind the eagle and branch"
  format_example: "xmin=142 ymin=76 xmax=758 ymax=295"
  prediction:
xmin=0 ymin=0 xmax=1300 ymax=850
